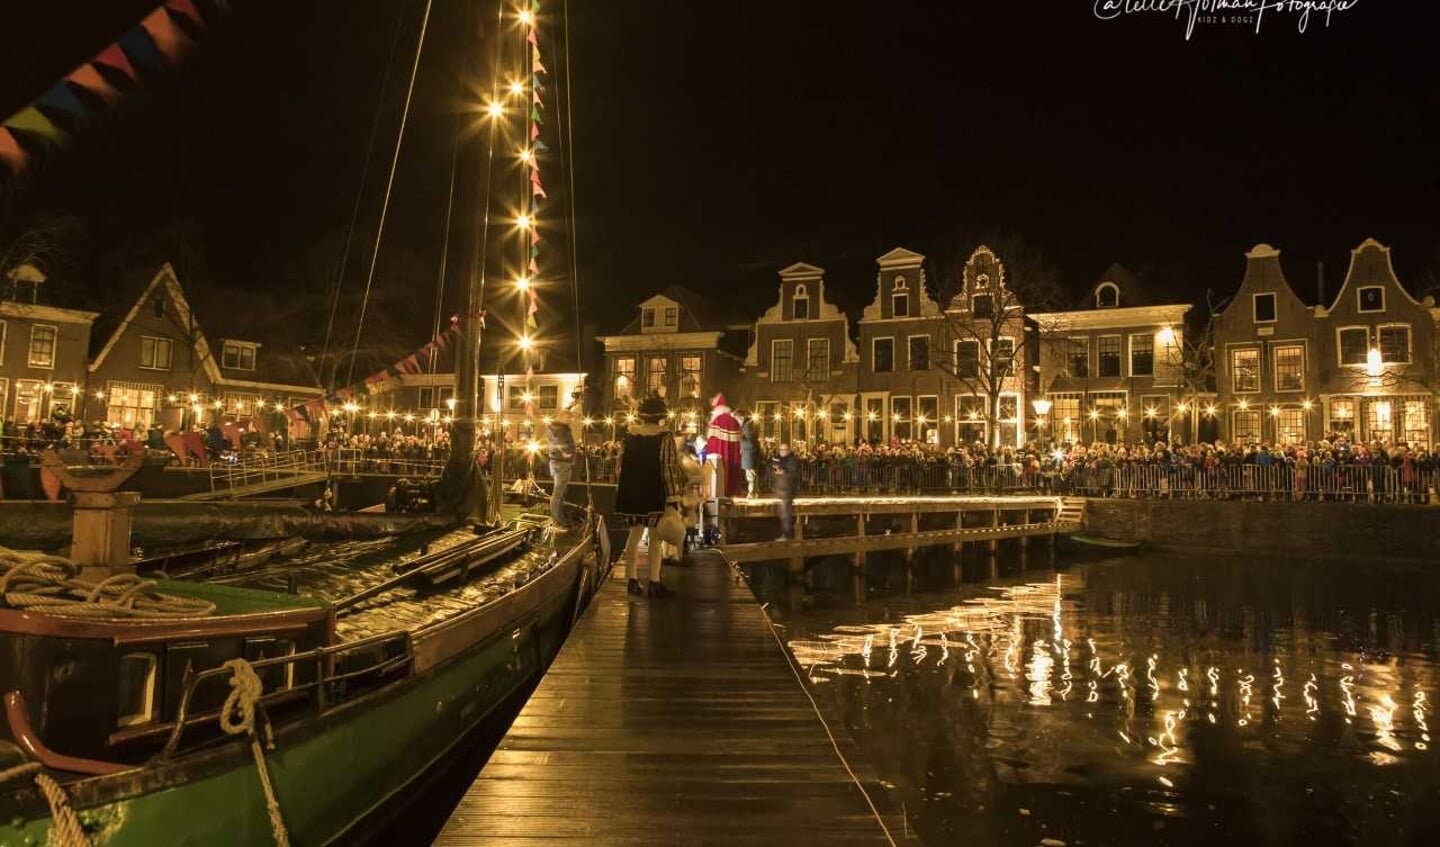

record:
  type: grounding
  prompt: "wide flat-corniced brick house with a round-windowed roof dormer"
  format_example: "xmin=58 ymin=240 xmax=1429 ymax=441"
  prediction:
xmin=1028 ymin=264 xmax=1192 ymax=442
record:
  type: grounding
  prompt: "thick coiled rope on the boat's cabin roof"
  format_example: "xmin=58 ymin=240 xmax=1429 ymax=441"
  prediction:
xmin=0 ymin=547 xmax=215 ymax=619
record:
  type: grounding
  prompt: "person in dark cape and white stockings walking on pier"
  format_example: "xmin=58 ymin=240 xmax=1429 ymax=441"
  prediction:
xmin=615 ymin=398 xmax=685 ymax=596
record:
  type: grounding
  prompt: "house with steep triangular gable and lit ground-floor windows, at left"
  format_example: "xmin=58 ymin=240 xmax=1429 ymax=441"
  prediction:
xmin=89 ymin=264 xmax=321 ymax=429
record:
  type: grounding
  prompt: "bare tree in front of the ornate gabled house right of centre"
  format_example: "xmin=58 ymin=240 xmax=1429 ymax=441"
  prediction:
xmin=937 ymin=230 xmax=1061 ymax=447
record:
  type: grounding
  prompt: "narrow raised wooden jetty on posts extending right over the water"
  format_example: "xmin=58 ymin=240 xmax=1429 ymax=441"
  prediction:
xmin=720 ymin=496 xmax=1080 ymax=569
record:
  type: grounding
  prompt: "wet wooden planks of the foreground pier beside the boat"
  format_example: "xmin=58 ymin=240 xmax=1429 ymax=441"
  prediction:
xmin=435 ymin=553 xmax=886 ymax=847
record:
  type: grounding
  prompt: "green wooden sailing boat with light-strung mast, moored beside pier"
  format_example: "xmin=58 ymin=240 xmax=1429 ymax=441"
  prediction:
xmin=0 ymin=0 xmax=603 ymax=847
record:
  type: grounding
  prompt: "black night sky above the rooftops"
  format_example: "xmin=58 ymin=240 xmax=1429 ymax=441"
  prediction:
xmin=0 ymin=0 xmax=1440 ymax=344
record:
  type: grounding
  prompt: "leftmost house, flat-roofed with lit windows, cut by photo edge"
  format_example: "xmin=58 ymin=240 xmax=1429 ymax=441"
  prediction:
xmin=0 ymin=275 xmax=99 ymax=425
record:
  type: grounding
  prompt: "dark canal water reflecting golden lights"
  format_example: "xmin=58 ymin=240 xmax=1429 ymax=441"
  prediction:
xmin=752 ymin=553 xmax=1440 ymax=847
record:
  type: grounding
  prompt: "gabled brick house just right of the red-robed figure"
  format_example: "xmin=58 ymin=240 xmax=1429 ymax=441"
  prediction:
xmin=732 ymin=262 xmax=860 ymax=444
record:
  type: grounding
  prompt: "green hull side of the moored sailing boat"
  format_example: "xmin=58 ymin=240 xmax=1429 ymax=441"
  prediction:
xmin=0 ymin=538 xmax=586 ymax=847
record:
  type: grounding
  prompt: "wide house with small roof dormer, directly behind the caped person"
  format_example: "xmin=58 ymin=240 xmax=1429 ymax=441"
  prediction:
xmin=599 ymin=285 xmax=750 ymax=426
